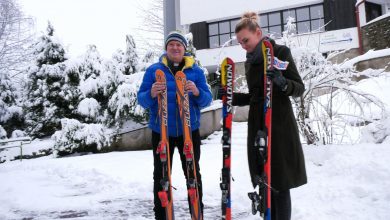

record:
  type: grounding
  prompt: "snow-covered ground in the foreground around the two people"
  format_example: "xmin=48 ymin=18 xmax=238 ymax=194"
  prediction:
xmin=0 ymin=123 xmax=390 ymax=220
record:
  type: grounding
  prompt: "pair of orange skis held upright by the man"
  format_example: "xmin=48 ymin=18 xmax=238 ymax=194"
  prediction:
xmin=156 ymin=70 xmax=203 ymax=220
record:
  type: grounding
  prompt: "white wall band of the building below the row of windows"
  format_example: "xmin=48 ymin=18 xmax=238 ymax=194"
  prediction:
xmin=196 ymin=28 xmax=359 ymax=69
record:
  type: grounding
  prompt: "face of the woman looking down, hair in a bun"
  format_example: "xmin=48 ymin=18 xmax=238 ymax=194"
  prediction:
xmin=236 ymin=28 xmax=262 ymax=53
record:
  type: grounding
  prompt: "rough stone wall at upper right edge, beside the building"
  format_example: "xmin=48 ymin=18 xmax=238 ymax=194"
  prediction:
xmin=362 ymin=16 xmax=390 ymax=53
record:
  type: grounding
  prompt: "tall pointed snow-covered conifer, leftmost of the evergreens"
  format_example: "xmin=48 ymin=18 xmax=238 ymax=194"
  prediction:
xmin=24 ymin=23 xmax=68 ymax=137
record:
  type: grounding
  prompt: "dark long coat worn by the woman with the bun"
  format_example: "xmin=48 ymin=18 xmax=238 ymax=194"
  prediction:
xmin=233 ymin=41 xmax=307 ymax=190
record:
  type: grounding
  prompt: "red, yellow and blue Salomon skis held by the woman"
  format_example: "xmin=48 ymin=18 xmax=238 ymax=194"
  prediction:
xmin=220 ymin=39 xmax=274 ymax=220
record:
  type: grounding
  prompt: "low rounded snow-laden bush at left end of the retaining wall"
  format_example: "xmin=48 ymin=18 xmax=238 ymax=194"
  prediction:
xmin=52 ymin=118 xmax=112 ymax=156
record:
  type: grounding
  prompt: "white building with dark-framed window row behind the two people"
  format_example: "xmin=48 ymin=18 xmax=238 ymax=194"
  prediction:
xmin=164 ymin=0 xmax=390 ymax=75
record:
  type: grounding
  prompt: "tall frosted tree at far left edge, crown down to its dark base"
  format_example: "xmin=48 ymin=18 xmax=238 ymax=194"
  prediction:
xmin=0 ymin=0 xmax=32 ymax=136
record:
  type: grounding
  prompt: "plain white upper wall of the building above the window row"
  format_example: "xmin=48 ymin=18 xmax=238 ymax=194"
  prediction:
xmin=180 ymin=0 xmax=323 ymax=25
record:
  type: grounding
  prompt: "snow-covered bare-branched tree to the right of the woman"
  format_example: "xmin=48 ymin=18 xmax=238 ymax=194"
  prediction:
xmin=282 ymin=18 xmax=386 ymax=144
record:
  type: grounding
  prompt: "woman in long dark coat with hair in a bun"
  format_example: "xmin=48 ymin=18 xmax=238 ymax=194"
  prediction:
xmin=233 ymin=12 xmax=307 ymax=220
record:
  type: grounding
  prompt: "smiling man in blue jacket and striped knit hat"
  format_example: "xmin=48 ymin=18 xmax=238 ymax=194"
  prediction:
xmin=137 ymin=31 xmax=212 ymax=220
